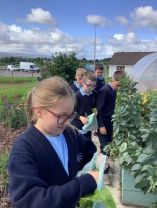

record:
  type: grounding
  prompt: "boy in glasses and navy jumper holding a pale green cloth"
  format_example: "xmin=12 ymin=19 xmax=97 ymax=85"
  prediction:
xmin=72 ymin=71 xmax=96 ymax=139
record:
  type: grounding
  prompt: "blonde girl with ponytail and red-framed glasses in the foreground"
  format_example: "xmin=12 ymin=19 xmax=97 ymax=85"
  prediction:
xmin=8 ymin=77 xmax=98 ymax=208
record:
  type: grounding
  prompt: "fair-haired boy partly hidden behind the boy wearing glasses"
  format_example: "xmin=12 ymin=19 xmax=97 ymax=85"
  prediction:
xmin=71 ymin=68 xmax=86 ymax=92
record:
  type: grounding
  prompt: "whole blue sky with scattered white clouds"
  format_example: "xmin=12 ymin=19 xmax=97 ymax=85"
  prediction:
xmin=0 ymin=0 xmax=157 ymax=59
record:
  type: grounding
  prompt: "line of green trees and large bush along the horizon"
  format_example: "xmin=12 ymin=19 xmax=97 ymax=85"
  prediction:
xmin=0 ymin=52 xmax=110 ymax=83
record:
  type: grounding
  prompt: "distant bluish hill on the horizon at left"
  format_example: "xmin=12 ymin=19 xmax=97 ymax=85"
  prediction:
xmin=0 ymin=52 xmax=51 ymax=58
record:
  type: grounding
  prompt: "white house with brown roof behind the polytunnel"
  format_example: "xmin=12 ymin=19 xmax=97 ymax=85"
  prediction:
xmin=109 ymin=52 xmax=154 ymax=77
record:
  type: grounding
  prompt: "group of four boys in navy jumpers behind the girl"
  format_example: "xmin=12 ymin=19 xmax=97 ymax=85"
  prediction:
xmin=71 ymin=65 xmax=125 ymax=154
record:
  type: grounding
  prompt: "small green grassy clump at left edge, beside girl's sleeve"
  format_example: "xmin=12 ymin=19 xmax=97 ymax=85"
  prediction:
xmin=0 ymin=151 xmax=9 ymax=189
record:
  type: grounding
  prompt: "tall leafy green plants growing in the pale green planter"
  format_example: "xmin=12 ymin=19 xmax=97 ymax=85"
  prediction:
xmin=106 ymin=77 xmax=157 ymax=192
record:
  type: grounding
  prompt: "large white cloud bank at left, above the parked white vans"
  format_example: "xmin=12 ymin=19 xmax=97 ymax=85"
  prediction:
xmin=0 ymin=24 xmax=75 ymax=55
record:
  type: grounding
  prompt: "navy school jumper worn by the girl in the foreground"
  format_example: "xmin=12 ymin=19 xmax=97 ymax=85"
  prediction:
xmin=8 ymin=126 xmax=96 ymax=208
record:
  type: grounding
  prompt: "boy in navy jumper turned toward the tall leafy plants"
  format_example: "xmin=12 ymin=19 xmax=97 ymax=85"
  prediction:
xmin=96 ymin=70 xmax=126 ymax=154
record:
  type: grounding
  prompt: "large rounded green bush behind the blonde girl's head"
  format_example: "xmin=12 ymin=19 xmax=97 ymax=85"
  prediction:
xmin=41 ymin=52 xmax=80 ymax=83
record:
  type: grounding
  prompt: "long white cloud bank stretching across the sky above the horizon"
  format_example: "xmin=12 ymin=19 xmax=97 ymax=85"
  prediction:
xmin=0 ymin=23 xmax=157 ymax=60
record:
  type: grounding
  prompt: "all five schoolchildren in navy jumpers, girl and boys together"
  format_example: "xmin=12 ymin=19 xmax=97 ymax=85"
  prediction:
xmin=8 ymin=64 xmax=126 ymax=208
